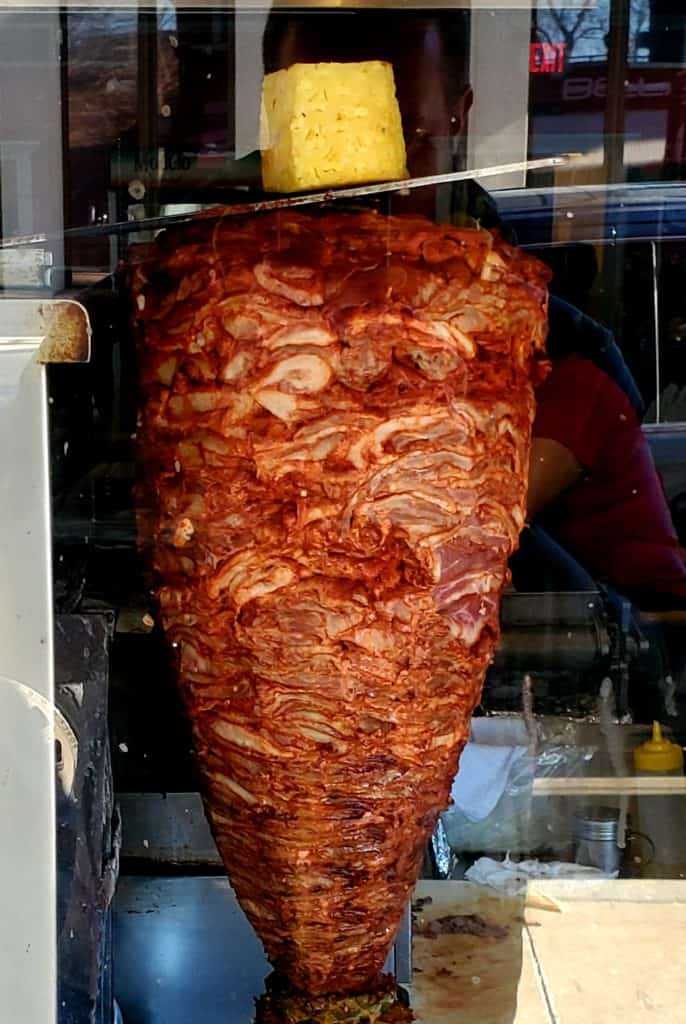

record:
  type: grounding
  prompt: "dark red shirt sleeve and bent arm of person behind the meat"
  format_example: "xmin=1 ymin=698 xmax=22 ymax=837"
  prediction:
xmin=515 ymin=353 xmax=686 ymax=610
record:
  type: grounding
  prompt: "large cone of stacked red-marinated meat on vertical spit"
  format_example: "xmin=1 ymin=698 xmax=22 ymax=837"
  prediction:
xmin=133 ymin=207 xmax=547 ymax=995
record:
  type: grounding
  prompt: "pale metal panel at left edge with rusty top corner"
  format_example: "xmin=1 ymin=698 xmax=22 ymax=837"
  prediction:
xmin=0 ymin=300 xmax=89 ymax=1024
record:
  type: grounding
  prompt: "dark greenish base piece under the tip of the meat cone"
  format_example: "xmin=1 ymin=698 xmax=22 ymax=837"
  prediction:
xmin=255 ymin=974 xmax=415 ymax=1024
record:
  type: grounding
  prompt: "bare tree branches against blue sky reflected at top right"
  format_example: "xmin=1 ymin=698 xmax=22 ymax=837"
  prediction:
xmin=535 ymin=0 xmax=650 ymax=60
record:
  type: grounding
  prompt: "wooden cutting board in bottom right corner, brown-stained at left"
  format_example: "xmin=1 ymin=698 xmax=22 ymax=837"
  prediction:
xmin=412 ymin=880 xmax=686 ymax=1024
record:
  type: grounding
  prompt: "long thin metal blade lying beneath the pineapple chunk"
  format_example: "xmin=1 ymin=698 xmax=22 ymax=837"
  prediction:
xmin=0 ymin=154 xmax=572 ymax=249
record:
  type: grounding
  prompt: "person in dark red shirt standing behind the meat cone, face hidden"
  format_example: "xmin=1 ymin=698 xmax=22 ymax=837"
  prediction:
xmin=263 ymin=10 xmax=686 ymax=609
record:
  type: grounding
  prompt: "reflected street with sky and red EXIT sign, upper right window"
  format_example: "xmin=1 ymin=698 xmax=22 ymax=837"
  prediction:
xmin=529 ymin=0 xmax=686 ymax=182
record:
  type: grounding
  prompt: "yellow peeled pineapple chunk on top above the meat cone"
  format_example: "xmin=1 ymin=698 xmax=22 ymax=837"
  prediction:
xmin=260 ymin=60 xmax=408 ymax=193
